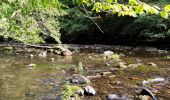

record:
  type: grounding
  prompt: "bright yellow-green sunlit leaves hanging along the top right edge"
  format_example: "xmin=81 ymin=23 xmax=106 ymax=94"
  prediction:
xmin=76 ymin=0 xmax=170 ymax=18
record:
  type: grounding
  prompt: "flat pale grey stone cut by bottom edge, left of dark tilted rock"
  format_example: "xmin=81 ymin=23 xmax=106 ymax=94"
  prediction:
xmin=106 ymin=94 xmax=131 ymax=100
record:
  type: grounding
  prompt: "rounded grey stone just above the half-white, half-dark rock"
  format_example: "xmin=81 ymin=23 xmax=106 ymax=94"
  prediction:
xmin=71 ymin=75 xmax=91 ymax=84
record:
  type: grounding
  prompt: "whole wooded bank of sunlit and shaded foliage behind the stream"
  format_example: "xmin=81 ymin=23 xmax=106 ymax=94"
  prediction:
xmin=0 ymin=0 xmax=170 ymax=45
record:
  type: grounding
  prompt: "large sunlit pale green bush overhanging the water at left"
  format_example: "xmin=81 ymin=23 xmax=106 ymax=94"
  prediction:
xmin=0 ymin=0 xmax=63 ymax=44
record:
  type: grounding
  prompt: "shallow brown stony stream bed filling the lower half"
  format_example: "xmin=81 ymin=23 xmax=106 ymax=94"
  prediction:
xmin=0 ymin=45 xmax=170 ymax=100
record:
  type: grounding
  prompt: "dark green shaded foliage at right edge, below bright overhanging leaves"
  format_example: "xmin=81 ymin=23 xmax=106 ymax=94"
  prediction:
xmin=123 ymin=15 xmax=170 ymax=39
